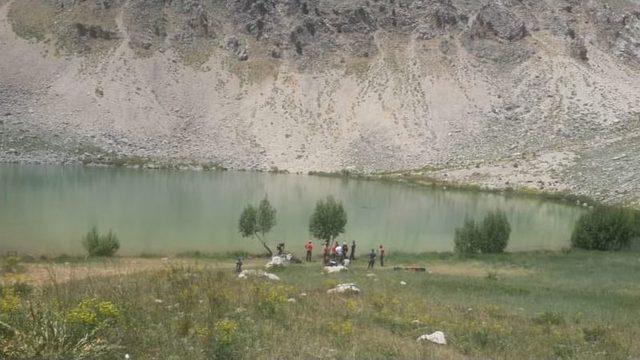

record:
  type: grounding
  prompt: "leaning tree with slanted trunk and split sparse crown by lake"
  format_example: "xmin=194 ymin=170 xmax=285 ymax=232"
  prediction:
xmin=238 ymin=196 xmax=276 ymax=256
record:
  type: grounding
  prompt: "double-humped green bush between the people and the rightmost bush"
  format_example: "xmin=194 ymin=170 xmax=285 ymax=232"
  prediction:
xmin=453 ymin=210 xmax=511 ymax=255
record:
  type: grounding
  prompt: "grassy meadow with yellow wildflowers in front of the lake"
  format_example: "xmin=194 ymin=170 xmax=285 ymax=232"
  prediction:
xmin=0 ymin=251 xmax=640 ymax=359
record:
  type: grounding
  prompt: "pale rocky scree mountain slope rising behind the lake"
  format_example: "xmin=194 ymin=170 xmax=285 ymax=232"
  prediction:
xmin=0 ymin=0 xmax=640 ymax=204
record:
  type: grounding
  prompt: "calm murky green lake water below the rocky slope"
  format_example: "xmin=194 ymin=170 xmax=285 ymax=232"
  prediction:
xmin=0 ymin=165 xmax=583 ymax=255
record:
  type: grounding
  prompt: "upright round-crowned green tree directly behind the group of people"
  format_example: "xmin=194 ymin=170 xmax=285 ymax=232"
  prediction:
xmin=309 ymin=196 xmax=347 ymax=243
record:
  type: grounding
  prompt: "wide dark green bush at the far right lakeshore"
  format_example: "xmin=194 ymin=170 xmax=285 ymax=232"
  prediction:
xmin=571 ymin=207 xmax=637 ymax=251
